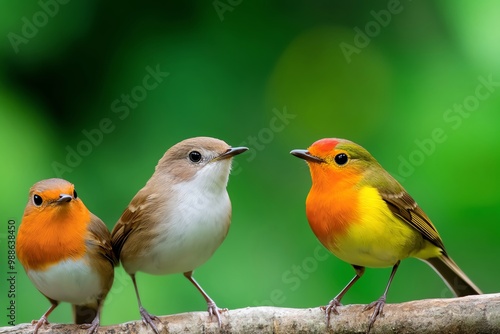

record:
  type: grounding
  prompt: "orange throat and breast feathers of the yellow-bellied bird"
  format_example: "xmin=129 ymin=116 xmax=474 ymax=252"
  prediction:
xmin=306 ymin=164 xmax=362 ymax=250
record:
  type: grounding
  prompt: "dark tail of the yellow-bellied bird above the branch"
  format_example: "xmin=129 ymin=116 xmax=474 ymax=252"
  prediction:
xmin=424 ymin=255 xmax=482 ymax=297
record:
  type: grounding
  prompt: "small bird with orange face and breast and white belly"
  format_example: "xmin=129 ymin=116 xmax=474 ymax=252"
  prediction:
xmin=16 ymin=179 xmax=116 ymax=333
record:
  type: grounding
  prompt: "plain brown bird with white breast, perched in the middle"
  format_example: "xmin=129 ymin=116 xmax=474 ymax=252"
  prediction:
xmin=111 ymin=137 xmax=247 ymax=333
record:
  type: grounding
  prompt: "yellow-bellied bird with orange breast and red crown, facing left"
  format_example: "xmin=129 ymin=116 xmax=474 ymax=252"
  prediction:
xmin=290 ymin=138 xmax=481 ymax=332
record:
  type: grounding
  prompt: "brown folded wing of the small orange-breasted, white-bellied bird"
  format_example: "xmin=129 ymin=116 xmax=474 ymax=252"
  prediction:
xmin=86 ymin=214 xmax=118 ymax=266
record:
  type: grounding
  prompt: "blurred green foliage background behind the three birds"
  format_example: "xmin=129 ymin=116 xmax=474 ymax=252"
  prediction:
xmin=0 ymin=0 xmax=500 ymax=325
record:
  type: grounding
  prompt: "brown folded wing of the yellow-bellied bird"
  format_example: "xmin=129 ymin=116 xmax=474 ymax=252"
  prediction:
xmin=380 ymin=186 xmax=444 ymax=251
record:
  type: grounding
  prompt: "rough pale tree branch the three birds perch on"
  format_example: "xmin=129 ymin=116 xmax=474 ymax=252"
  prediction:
xmin=0 ymin=294 xmax=500 ymax=334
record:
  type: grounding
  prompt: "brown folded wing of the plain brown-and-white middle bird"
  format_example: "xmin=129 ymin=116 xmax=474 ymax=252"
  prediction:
xmin=111 ymin=188 xmax=159 ymax=260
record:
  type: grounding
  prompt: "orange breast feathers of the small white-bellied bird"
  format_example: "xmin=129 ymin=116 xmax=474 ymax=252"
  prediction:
xmin=16 ymin=199 xmax=90 ymax=270
